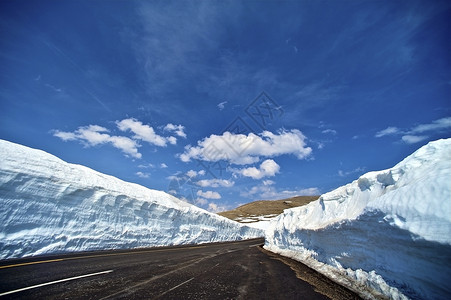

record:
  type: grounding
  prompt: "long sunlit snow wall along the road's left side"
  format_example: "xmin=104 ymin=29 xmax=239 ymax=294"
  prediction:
xmin=0 ymin=140 xmax=263 ymax=259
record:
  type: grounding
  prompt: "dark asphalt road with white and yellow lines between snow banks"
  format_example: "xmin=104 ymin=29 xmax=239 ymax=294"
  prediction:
xmin=0 ymin=239 xmax=357 ymax=299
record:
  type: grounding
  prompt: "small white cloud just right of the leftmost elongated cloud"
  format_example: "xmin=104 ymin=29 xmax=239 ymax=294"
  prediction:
xmin=116 ymin=118 xmax=168 ymax=147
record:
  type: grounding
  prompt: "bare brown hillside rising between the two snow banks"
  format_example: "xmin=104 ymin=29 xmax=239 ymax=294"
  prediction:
xmin=218 ymin=196 xmax=319 ymax=220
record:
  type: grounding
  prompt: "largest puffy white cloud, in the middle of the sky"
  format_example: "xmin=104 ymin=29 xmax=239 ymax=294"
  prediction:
xmin=179 ymin=129 xmax=312 ymax=165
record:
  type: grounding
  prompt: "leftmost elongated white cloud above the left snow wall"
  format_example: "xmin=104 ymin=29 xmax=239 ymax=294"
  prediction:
xmin=53 ymin=125 xmax=142 ymax=158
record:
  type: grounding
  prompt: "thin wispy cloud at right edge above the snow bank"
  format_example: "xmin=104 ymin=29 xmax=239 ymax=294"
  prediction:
xmin=375 ymin=117 xmax=451 ymax=144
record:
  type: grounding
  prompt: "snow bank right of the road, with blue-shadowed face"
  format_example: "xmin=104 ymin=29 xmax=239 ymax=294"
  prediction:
xmin=265 ymin=139 xmax=451 ymax=299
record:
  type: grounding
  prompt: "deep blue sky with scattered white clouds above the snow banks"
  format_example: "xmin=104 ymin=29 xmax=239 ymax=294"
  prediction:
xmin=0 ymin=0 xmax=451 ymax=211
